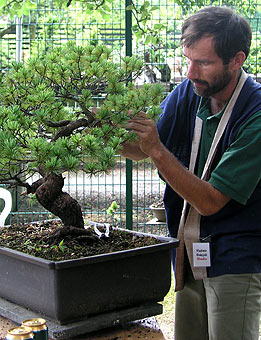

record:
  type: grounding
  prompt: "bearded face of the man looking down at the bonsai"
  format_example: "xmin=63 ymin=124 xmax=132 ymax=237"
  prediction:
xmin=183 ymin=37 xmax=232 ymax=97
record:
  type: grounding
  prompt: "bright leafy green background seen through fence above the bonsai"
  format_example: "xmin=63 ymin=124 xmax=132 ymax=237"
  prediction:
xmin=0 ymin=0 xmax=261 ymax=81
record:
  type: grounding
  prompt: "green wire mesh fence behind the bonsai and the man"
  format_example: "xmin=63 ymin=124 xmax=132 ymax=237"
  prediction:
xmin=0 ymin=0 xmax=261 ymax=234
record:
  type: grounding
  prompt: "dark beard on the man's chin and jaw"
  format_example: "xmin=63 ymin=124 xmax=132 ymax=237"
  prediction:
xmin=191 ymin=67 xmax=232 ymax=98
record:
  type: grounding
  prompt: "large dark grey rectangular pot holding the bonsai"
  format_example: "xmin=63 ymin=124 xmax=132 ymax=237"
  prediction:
xmin=0 ymin=230 xmax=178 ymax=324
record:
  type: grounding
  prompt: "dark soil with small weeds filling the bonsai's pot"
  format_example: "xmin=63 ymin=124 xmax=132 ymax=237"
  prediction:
xmin=0 ymin=220 xmax=160 ymax=261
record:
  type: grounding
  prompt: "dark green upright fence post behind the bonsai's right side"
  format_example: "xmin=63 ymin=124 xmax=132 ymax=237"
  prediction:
xmin=125 ymin=0 xmax=133 ymax=229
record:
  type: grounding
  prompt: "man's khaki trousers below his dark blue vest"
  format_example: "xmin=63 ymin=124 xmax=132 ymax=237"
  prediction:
xmin=174 ymin=269 xmax=261 ymax=340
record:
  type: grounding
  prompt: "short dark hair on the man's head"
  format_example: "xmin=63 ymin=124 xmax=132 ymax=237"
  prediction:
xmin=181 ymin=6 xmax=252 ymax=64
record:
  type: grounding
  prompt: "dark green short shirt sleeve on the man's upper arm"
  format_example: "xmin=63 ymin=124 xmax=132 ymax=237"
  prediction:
xmin=209 ymin=111 xmax=261 ymax=204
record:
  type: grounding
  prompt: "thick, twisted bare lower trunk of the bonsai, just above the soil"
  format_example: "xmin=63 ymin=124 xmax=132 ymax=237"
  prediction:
xmin=30 ymin=173 xmax=84 ymax=228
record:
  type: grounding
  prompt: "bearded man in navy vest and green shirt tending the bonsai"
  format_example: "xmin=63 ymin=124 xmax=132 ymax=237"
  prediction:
xmin=122 ymin=6 xmax=261 ymax=340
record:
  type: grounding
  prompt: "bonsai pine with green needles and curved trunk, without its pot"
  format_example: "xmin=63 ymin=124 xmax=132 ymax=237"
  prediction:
xmin=0 ymin=43 xmax=162 ymax=239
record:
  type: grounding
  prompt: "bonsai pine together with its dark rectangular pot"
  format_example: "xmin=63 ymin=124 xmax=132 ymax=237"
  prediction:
xmin=0 ymin=43 xmax=177 ymax=323
